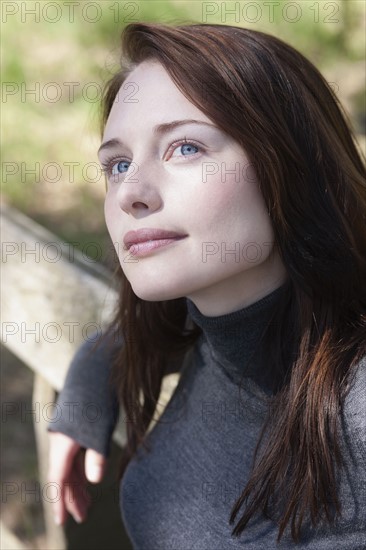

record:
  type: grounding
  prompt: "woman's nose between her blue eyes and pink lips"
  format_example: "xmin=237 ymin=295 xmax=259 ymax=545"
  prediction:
xmin=117 ymin=162 xmax=163 ymax=217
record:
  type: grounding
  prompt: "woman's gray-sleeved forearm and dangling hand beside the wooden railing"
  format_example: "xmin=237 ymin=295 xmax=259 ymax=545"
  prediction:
xmin=48 ymin=330 xmax=122 ymax=524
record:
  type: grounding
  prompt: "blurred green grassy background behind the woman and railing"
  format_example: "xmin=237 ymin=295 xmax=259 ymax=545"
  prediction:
xmin=1 ymin=0 xmax=366 ymax=548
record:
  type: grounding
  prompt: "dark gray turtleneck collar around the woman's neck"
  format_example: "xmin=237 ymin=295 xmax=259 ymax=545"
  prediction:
xmin=186 ymin=284 xmax=286 ymax=393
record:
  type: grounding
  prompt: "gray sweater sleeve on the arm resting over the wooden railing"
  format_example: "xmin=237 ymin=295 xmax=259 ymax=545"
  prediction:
xmin=47 ymin=335 xmax=122 ymax=457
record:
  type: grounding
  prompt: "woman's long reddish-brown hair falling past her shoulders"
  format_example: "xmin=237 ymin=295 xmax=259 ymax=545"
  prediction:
xmin=98 ymin=23 xmax=366 ymax=541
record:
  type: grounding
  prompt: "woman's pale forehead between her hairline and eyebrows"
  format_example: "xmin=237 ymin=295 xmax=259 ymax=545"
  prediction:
xmin=105 ymin=60 xmax=211 ymax=138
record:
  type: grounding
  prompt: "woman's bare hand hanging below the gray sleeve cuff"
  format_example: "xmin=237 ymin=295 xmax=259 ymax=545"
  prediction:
xmin=48 ymin=432 xmax=107 ymax=525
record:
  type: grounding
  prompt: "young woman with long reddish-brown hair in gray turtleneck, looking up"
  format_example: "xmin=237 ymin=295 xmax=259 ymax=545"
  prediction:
xmin=49 ymin=23 xmax=366 ymax=550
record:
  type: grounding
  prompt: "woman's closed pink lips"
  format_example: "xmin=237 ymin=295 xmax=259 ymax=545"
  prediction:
xmin=123 ymin=227 xmax=187 ymax=255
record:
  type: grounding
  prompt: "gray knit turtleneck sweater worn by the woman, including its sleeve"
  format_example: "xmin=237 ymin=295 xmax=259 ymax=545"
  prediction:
xmin=49 ymin=287 xmax=366 ymax=550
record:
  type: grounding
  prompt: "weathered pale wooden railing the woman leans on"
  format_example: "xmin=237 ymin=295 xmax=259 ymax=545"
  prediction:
xmin=1 ymin=205 xmax=178 ymax=550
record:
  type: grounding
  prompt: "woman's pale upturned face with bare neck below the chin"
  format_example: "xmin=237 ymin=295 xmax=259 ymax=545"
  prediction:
xmin=99 ymin=61 xmax=286 ymax=315
